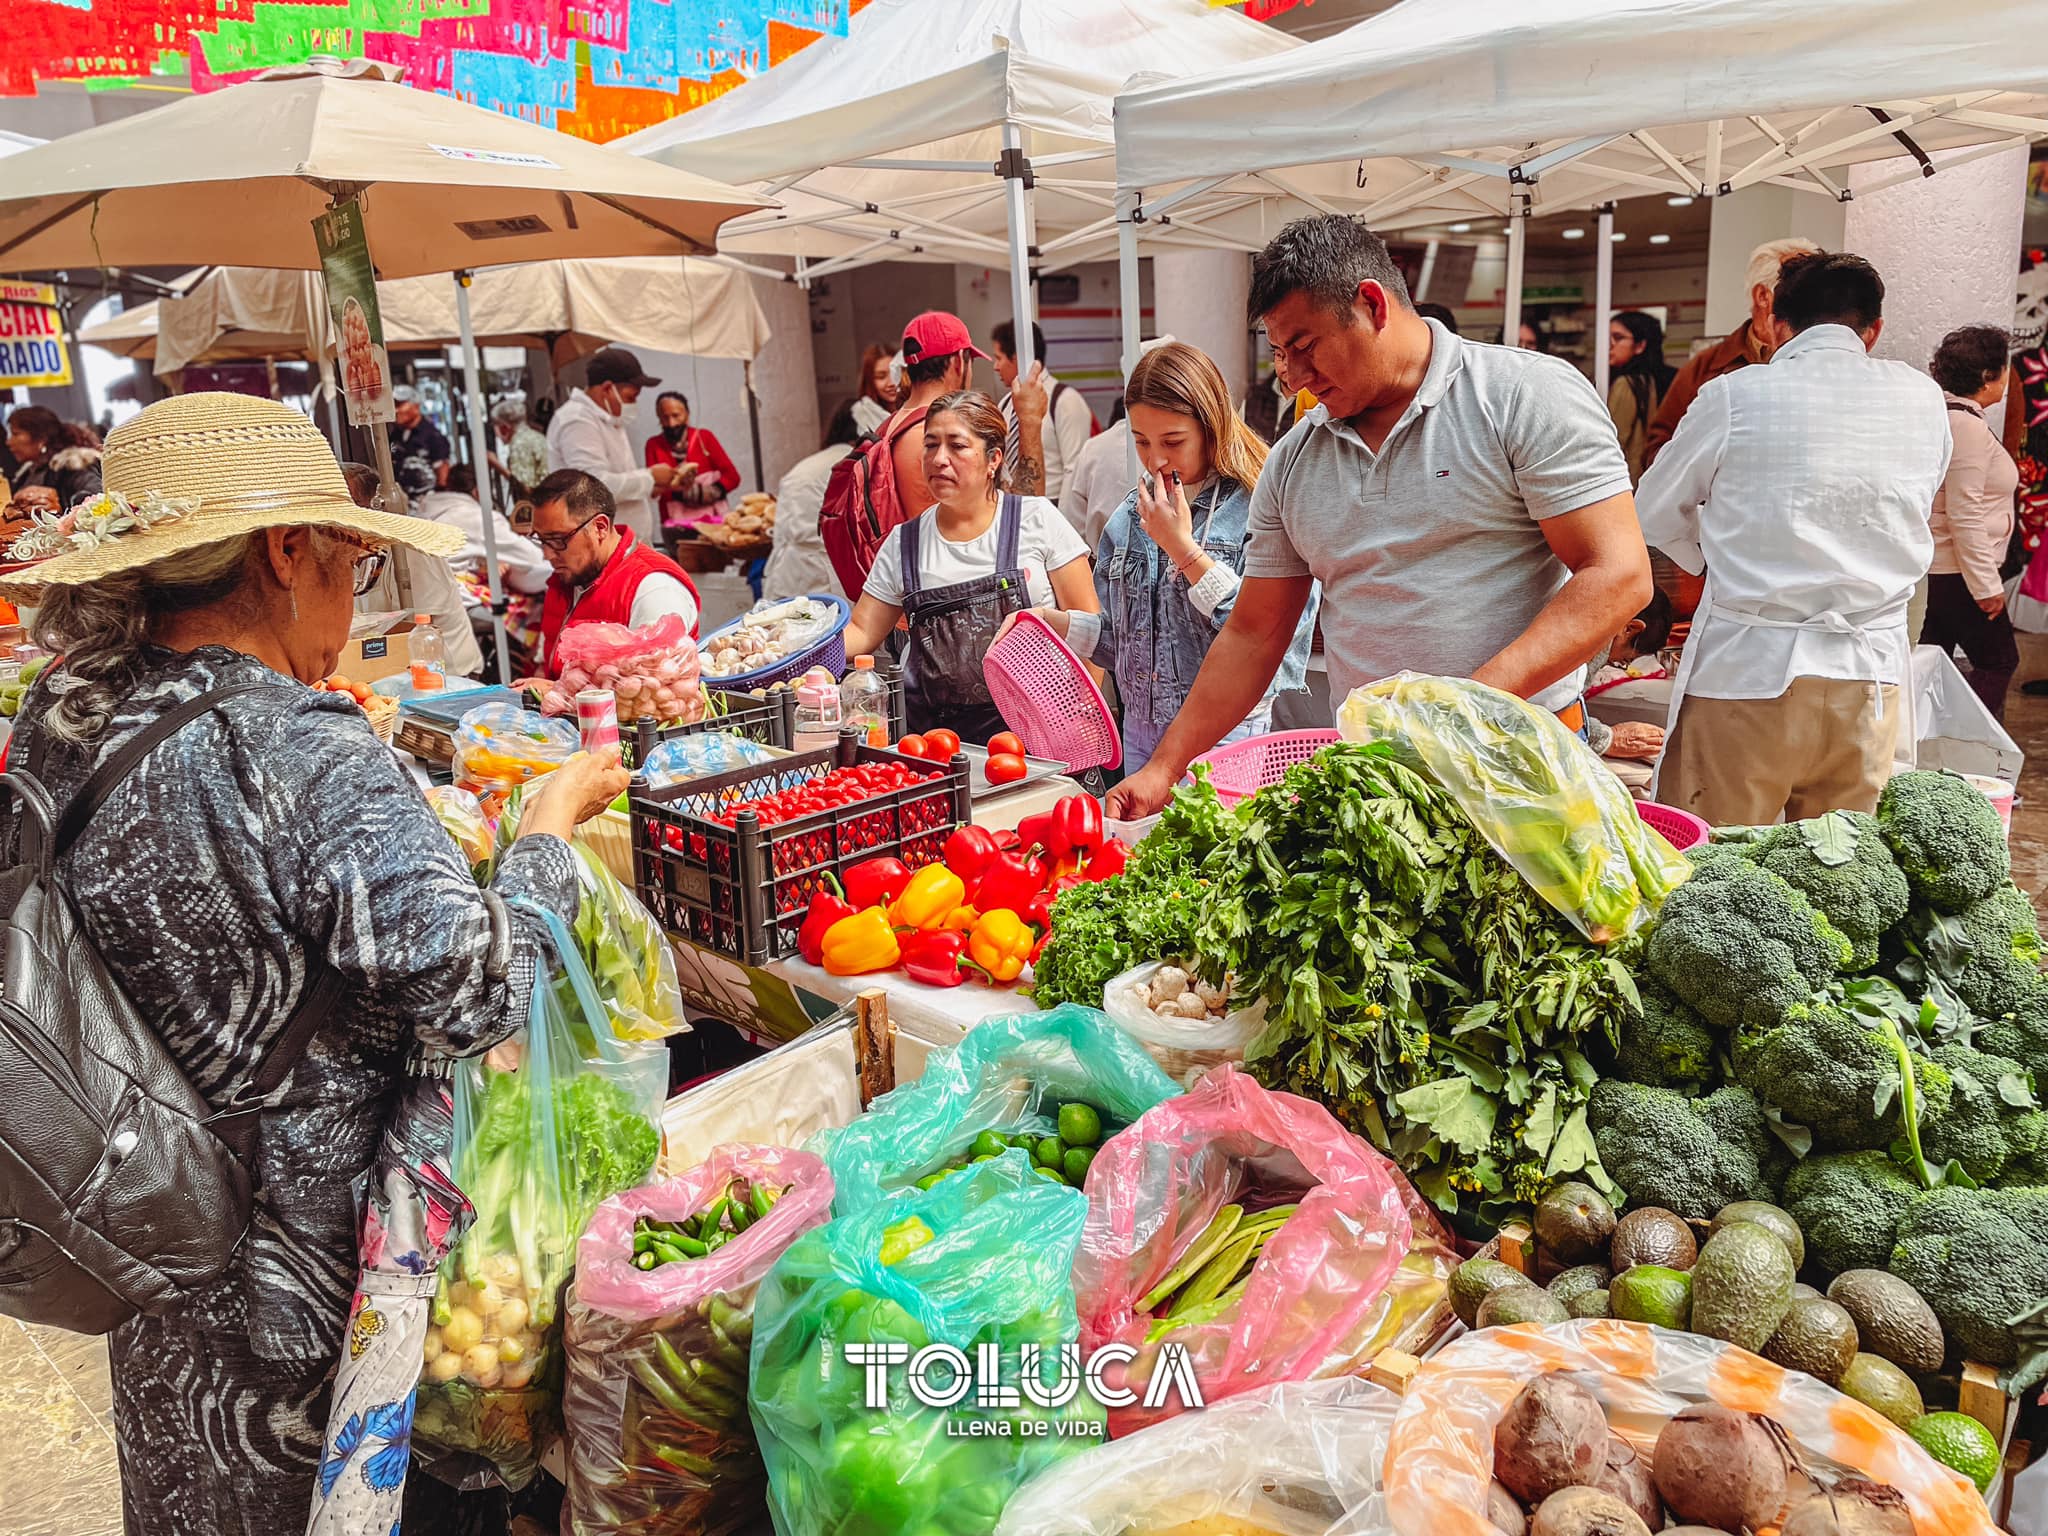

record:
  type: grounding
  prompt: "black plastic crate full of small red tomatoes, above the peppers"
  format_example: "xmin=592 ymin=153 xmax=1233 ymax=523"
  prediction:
xmin=633 ymin=729 xmax=971 ymax=965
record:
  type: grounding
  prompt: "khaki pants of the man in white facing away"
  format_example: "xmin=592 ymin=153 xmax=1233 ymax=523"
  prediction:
xmin=1657 ymin=678 xmax=1901 ymax=827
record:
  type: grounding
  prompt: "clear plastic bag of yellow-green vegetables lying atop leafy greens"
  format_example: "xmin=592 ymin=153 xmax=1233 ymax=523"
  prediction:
xmin=1337 ymin=672 xmax=1692 ymax=944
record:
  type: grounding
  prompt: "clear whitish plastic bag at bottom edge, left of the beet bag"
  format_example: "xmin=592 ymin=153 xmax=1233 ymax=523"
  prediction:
xmin=995 ymin=1376 xmax=1401 ymax=1536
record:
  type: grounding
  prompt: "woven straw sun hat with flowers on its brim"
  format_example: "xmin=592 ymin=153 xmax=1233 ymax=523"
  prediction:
xmin=0 ymin=393 xmax=463 ymax=602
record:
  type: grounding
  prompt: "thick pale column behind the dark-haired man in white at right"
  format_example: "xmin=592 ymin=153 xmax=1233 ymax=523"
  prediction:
xmin=1843 ymin=147 xmax=2028 ymax=405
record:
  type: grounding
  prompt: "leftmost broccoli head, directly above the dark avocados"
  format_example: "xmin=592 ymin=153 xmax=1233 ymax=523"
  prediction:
xmin=1585 ymin=1079 xmax=1788 ymax=1221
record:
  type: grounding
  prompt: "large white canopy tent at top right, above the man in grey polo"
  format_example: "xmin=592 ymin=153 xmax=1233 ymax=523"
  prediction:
xmin=1116 ymin=0 xmax=2048 ymax=399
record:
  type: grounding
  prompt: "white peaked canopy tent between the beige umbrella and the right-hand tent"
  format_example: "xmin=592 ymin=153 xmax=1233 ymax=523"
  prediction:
xmin=616 ymin=0 xmax=1298 ymax=367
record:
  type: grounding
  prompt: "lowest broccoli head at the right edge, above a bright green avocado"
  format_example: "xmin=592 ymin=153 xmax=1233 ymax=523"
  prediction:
xmin=1890 ymin=1186 xmax=2048 ymax=1386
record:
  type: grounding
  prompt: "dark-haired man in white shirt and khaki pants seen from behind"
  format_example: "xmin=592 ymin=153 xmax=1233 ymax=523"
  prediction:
xmin=1636 ymin=254 xmax=1950 ymax=825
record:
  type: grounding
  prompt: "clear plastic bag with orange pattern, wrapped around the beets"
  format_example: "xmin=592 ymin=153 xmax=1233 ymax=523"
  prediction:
xmin=1386 ymin=1321 xmax=1997 ymax=1536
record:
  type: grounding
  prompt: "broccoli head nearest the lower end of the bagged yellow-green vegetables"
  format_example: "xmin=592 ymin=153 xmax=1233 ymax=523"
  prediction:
xmin=1647 ymin=860 xmax=1853 ymax=1030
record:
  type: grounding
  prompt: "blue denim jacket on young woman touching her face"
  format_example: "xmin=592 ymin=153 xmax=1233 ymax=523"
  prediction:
xmin=1087 ymin=479 xmax=1321 ymax=768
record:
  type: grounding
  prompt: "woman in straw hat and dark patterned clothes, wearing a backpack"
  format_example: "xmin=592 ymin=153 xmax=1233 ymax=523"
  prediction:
xmin=4 ymin=393 xmax=625 ymax=1536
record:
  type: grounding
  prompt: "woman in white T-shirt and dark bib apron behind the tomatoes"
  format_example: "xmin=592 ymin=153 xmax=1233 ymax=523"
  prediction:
xmin=846 ymin=389 xmax=1096 ymax=741
